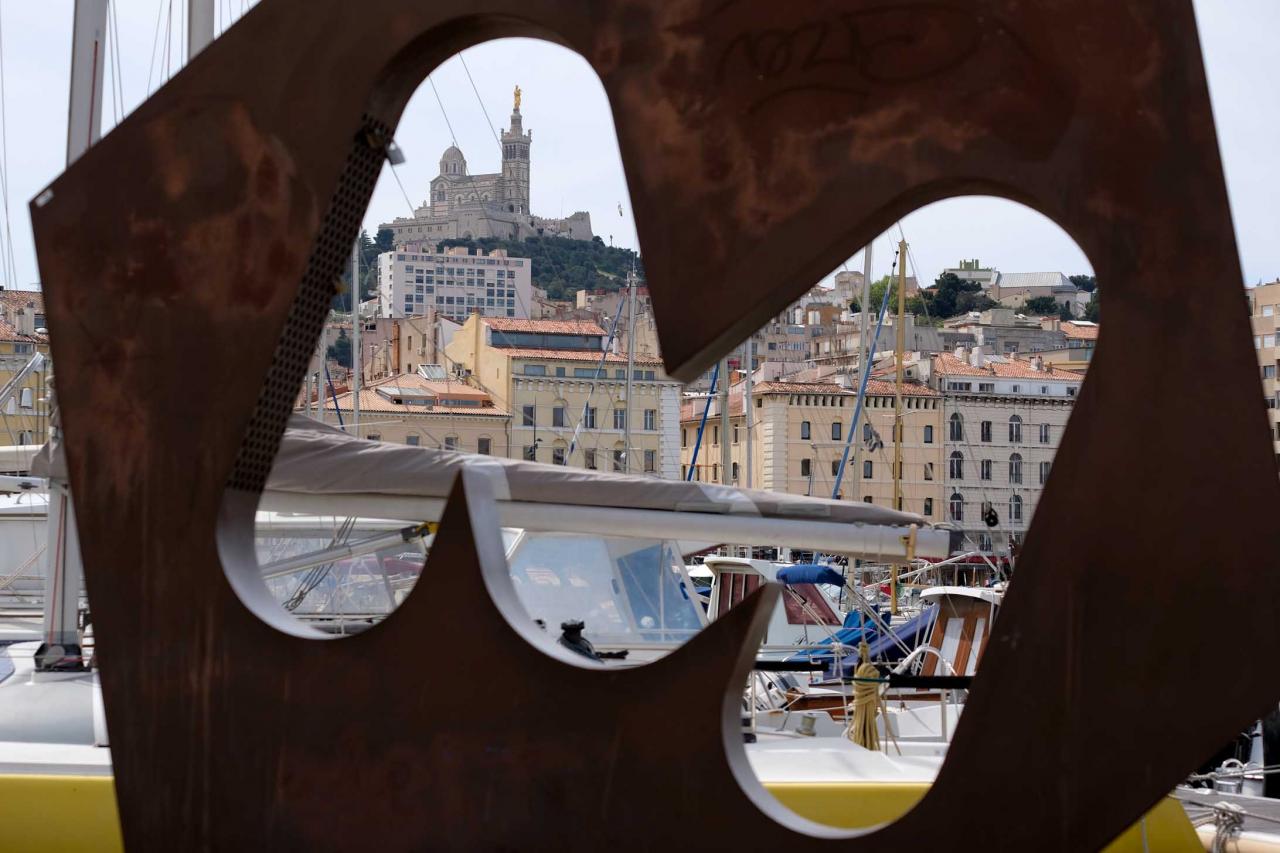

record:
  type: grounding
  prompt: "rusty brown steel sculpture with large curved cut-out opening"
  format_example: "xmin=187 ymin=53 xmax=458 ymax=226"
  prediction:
xmin=32 ymin=0 xmax=1280 ymax=850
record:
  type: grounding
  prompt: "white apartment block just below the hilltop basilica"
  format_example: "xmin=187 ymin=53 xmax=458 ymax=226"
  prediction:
xmin=378 ymin=243 xmax=534 ymax=323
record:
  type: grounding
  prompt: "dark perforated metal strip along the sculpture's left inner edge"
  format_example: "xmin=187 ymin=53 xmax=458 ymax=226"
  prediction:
xmin=227 ymin=115 xmax=390 ymax=492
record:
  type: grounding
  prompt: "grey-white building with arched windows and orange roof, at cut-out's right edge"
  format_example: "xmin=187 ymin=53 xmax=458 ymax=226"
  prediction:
xmin=931 ymin=350 xmax=1083 ymax=553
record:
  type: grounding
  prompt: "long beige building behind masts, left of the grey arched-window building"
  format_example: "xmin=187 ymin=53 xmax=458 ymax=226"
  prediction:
xmin=681 ymin=379 xmax=943 ymax=520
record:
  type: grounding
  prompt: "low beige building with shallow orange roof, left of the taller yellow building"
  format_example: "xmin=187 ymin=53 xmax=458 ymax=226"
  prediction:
xmin=314 ymin=374 xmax=511 ymax=456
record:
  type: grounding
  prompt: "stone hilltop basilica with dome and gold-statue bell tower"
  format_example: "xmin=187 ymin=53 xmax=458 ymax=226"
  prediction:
xmin=379 ymin=93 xmax=591 ymax=243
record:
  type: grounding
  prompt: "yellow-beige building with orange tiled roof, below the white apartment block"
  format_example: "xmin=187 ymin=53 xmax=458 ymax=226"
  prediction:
xmin=444 ymin=314 xmax=680 ymax=478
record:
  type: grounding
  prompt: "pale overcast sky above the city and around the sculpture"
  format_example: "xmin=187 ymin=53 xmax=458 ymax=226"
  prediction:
xmin=0 ymin=0 xmax=1280 ymax=287
